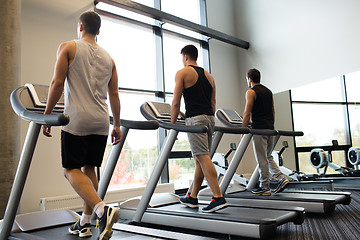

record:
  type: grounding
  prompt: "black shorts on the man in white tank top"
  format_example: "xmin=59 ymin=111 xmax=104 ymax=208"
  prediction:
xmin=61 ymin=131 xmax=107 ymax=169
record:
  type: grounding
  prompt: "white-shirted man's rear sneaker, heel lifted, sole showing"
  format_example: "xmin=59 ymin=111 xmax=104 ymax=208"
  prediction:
xmin=98 ymin=206 xmax=120 ymax=240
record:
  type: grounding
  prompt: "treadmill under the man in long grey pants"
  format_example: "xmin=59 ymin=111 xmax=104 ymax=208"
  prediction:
xmin=199 ymin=110 xmax=351 ymax=213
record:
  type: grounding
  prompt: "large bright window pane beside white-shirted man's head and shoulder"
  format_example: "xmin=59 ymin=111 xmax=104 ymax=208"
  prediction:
xmin=98 ymin=17 xmax=156 ymax=90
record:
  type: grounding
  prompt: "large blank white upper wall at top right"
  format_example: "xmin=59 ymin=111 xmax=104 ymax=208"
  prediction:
xmin=235 ymin=0 xmax=360 ymax=92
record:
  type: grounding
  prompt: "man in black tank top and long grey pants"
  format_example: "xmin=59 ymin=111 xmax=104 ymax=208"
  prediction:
xmin=242 ymin=69 xmax=289 ymax=196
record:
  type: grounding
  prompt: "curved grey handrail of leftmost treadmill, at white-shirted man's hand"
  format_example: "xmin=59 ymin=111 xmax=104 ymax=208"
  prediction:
xmin=10 ymin=87 xmax=70 ymax=126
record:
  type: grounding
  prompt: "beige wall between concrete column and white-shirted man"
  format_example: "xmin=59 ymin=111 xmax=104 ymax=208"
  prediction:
xmin=19 ymin=0 xmax=93 ymax=213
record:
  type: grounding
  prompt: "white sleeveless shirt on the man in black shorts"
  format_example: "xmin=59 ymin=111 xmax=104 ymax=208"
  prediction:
xmin=62 ymin=40 xmax=113 ymax=136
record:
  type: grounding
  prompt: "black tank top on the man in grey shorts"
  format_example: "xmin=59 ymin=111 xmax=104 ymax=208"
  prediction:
xmin=183 ymin=65 xmax=214 ymax=118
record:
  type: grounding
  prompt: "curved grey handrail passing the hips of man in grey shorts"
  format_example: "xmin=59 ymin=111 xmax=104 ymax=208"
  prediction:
xmin=140 ymin=102 xmax=208 ymax=133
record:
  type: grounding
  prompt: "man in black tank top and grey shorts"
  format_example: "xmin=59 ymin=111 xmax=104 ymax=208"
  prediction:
xmin=171 ymin=45 xmax=227 ymax=212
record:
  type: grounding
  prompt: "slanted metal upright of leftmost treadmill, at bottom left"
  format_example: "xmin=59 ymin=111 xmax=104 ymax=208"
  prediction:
xmin=0 ymin=122 xmax=41 ymax=240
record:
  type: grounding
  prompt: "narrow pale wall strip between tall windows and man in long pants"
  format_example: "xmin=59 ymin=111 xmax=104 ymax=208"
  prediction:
xmin=207 ymin=0 xmax=256 ymax=174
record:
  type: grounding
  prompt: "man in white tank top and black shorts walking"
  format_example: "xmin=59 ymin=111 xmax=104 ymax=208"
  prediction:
xmin=43 ymin=11 xmax=121 ymax=240
